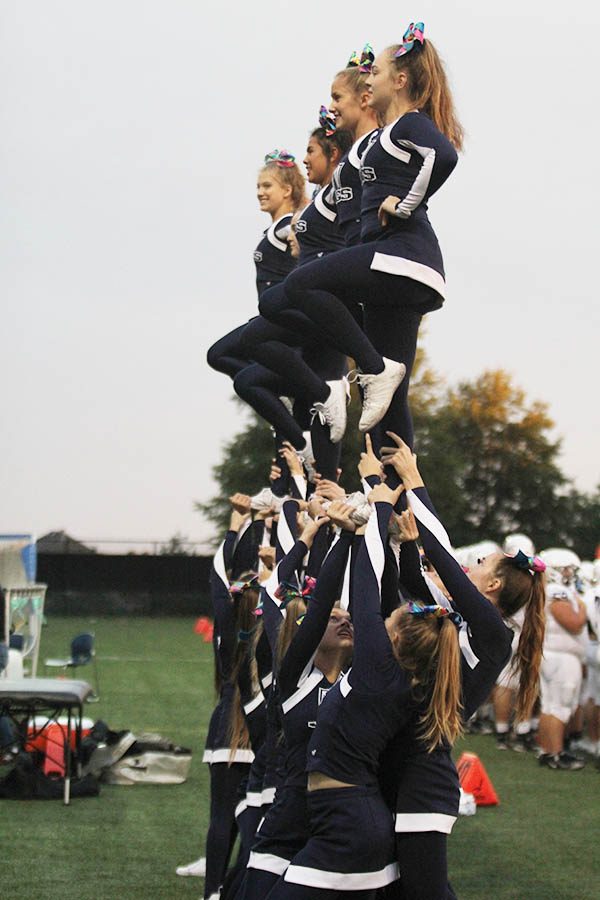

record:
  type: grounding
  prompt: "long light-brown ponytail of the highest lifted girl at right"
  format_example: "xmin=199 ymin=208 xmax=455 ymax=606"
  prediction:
xmin=388 ymin=40 xmax=464 ymax=150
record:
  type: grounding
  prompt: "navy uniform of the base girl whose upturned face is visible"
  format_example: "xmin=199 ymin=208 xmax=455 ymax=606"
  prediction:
xmin=241 ymin=536 xmax=351 ymax=900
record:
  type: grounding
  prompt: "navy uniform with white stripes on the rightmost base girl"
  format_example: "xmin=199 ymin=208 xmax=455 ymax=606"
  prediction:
xmin=382 ymin=487 xmax=512 ymax=900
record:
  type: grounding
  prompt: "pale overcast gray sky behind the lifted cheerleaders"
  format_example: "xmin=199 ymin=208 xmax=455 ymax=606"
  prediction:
xmin=0 ymin=0 xmax=600 ymax=539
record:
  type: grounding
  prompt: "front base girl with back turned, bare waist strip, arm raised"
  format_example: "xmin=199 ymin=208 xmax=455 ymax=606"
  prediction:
xmin=269 ymin=484 xmax=460 ymax=900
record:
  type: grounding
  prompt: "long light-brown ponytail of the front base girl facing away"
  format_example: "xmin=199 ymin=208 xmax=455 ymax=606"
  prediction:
xmin=397 ymin=608 xmax=462 ymax=753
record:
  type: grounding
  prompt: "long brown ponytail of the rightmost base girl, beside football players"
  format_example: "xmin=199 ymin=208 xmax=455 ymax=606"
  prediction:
xmin=495 ymin=557 xmax=546 ymax=722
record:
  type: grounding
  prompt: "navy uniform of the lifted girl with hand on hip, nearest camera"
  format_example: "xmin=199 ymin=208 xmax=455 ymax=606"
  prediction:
xmin=259 ymin=111 xmax=457 ymax=451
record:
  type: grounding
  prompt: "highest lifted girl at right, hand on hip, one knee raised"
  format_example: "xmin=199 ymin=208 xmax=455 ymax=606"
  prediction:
xmin=259 ymin=23 xmax=462 ymax=444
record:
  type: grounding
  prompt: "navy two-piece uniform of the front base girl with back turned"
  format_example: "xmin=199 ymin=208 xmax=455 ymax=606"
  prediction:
xmin=269 ymin=503 xmax=410 ymax=900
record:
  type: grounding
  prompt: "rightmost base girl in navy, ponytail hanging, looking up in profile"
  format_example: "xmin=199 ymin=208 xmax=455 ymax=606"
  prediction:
xmin=382 ymin=433 xmax=545 ymax=900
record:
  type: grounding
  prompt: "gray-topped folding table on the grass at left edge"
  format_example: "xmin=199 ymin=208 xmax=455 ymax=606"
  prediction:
xmin=0 ymin=678 xmax=93 ymax=805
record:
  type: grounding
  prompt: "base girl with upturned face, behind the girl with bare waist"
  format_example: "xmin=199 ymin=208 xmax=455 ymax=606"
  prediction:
xmin=238 ymin=517 xmax=352 ymax=900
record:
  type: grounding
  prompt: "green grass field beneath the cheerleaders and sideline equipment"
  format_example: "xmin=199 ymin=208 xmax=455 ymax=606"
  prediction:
xmin=0 ymin=618 xmax=600 ymax=900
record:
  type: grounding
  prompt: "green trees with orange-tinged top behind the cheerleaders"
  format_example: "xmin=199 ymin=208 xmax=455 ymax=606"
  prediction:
xmin=196 ymin=366 xmax=600 ymax=558
